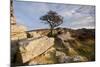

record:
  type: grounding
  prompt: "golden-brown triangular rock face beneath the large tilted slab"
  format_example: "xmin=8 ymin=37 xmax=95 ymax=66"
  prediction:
xmin=29 ymin=47 xmax=57 ymax=65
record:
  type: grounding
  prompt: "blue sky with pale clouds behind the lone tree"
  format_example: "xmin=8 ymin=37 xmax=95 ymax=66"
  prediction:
xmin=13 ymin=0 xmax=95 ymax=30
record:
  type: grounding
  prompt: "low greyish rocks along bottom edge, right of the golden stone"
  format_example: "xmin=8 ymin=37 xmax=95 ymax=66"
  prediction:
xmin=56 ymin=51 xmax=88 ymax=63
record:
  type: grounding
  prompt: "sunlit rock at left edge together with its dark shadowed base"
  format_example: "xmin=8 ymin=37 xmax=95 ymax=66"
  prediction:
xmin=11 ymin=24 xmax=27 ymax=64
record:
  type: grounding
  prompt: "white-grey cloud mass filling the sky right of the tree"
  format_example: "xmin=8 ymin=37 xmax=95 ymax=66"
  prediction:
xmin=58 ymin=5 xmax=95 ymax=28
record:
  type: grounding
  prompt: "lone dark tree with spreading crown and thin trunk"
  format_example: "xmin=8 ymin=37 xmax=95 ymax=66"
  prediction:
xmin=40 ymin=11 xmax=63 ymax=36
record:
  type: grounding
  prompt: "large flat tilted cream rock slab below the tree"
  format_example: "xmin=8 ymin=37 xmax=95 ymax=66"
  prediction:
xmin=19 ymin=36 xmax=54 ymax=63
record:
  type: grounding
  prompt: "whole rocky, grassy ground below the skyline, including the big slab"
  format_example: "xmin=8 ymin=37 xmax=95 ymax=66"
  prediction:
xmin=11 ymin=28 xmax=95 ymax=65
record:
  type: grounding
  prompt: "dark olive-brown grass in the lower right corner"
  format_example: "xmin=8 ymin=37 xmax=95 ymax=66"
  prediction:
xmin=76 ymin=40 xmax=95 ymax=61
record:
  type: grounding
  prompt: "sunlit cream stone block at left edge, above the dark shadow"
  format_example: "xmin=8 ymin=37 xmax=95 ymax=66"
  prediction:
xmin=11 ymin=25 xmax=27 ymax=40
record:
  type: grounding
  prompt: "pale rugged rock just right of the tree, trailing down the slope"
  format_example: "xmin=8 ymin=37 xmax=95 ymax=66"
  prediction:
xmin=57 ymin=32 xmax=78 ymax=55
